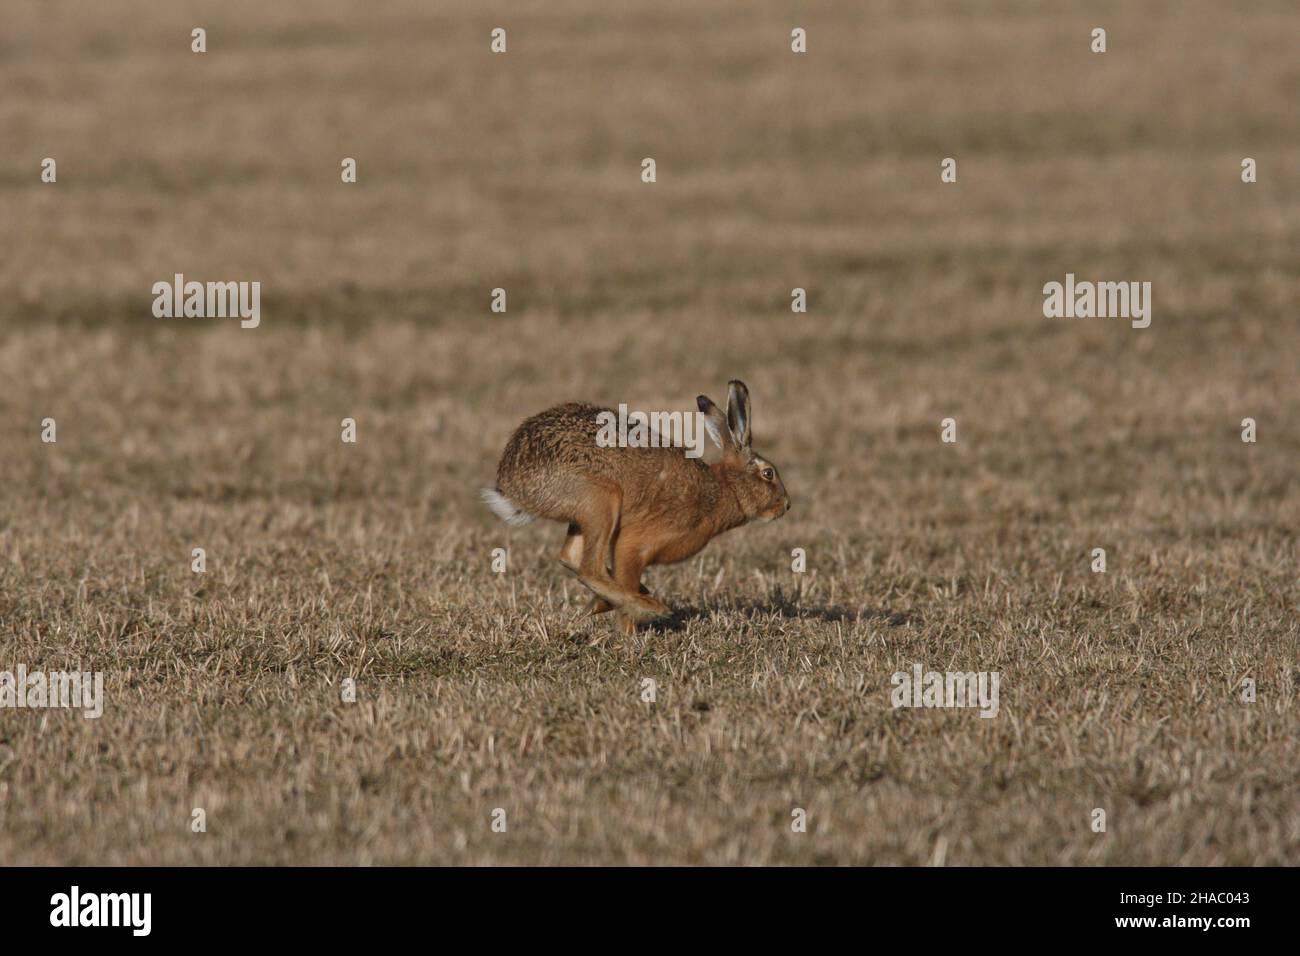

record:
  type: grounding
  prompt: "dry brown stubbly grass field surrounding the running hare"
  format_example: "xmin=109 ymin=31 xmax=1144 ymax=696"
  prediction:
xmin=0 ymin=0 xmax=1300 ymax=865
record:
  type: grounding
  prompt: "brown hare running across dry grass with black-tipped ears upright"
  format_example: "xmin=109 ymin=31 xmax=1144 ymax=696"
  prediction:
xmin=482 ymin=381 xmax=790 ymax=633
